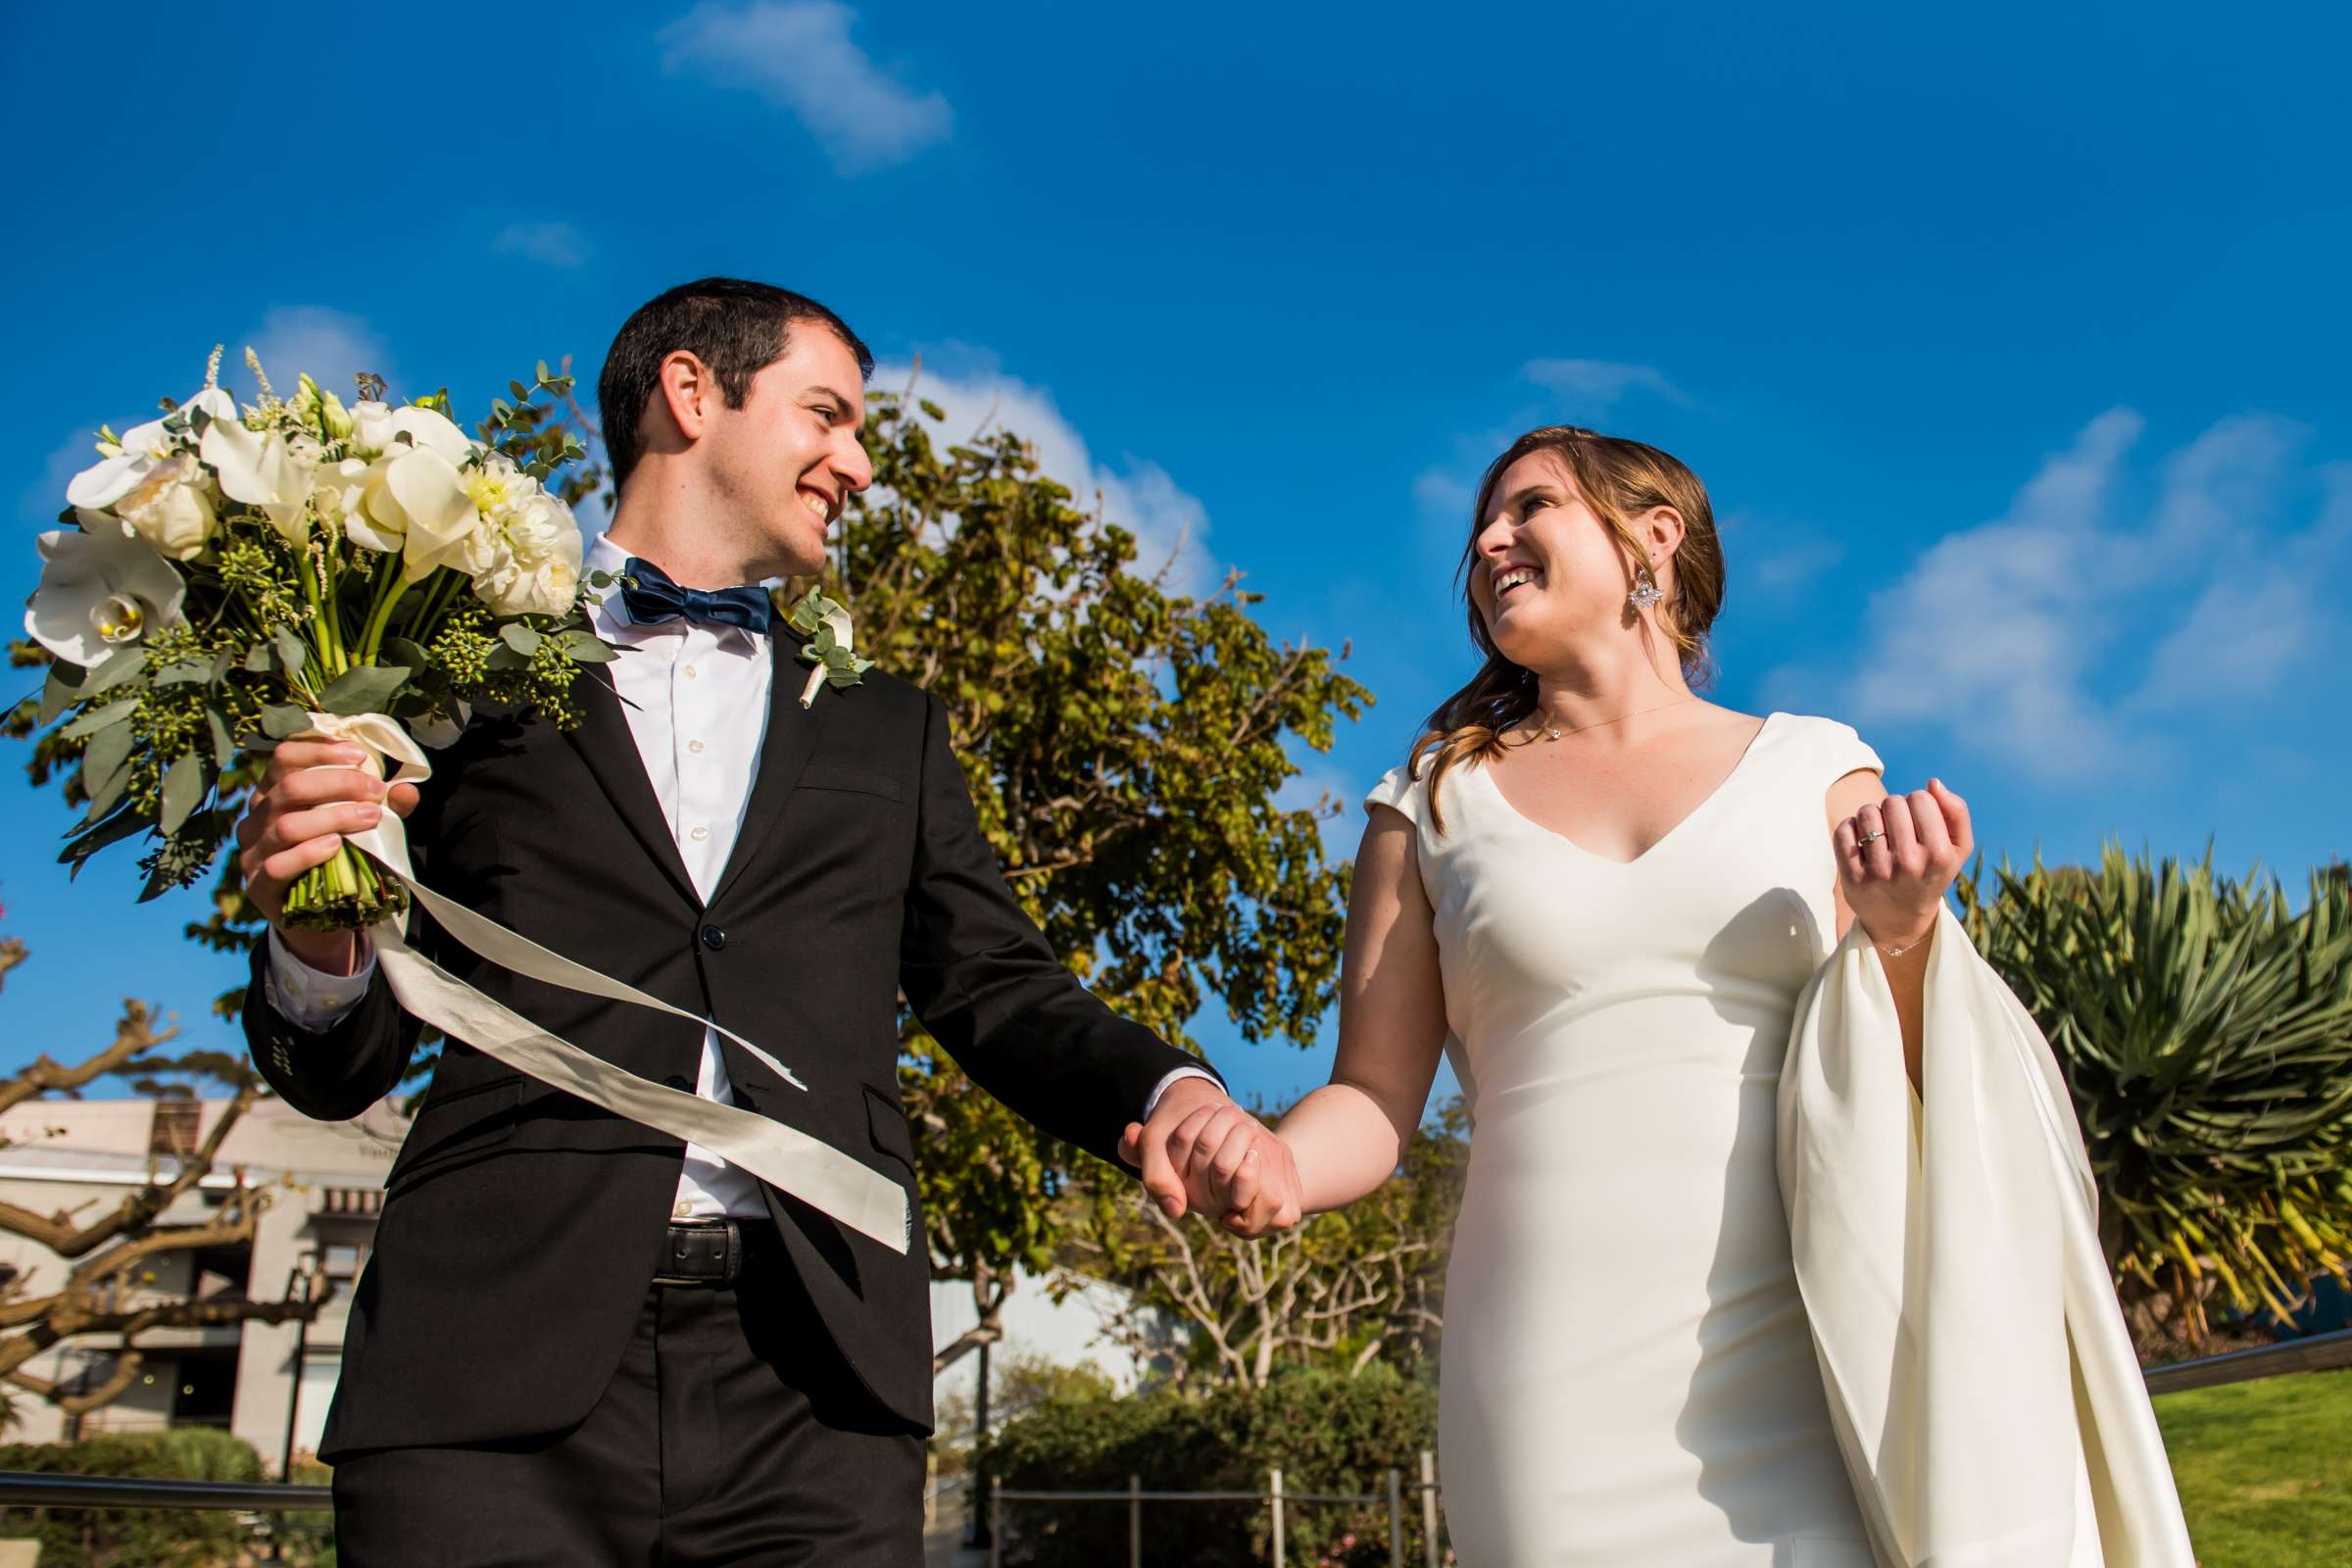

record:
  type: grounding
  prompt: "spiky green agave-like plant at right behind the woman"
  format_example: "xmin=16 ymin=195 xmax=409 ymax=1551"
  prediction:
xmin=1959 ymin=844 xmax=2352 ymax=1345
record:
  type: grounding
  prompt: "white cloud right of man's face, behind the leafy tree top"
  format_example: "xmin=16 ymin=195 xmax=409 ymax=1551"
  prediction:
xmin=872 ymin=365 xmax=1218 ymax=595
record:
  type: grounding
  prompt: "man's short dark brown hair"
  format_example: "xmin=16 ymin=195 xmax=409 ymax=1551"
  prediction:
xmin=595 ymin=277 xmax=875 ymax=491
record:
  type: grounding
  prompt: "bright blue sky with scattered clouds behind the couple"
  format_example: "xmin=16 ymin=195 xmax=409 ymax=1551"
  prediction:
xmin=0 ymin=0 xmax=2352 ymax=1101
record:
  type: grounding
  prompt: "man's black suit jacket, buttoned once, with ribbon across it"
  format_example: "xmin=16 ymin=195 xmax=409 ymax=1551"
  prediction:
xmin=245 ymin=627 xmax=1193 ymax=1460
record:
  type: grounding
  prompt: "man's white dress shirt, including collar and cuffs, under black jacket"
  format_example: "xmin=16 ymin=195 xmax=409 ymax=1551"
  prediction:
xmin=266 ymin=534 xmax=1213 ymax=1220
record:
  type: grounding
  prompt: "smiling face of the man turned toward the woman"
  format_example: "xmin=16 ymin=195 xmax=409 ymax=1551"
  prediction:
xmin=706 ymin=322 xmax=875 ymax=576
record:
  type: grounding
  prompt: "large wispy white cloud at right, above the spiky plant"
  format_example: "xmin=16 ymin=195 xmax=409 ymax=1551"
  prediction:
xmin=1825 ymin=409 xmax=2324 ymax=778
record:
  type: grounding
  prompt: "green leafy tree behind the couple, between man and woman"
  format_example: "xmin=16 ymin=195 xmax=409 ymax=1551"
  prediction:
xmin=804 ymin=393 xmax=1371 ymax=1366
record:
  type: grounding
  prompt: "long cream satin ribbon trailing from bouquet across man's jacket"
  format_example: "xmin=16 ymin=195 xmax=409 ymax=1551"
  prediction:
xmin=311 ymin=712 xmax=912 ymax=1253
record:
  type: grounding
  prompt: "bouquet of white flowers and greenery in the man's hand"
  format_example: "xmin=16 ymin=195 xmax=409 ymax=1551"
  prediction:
xmin=24 ymin=350 xmax=613 ymax=931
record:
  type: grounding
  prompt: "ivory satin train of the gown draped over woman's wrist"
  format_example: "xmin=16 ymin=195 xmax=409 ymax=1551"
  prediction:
xmin=1778 ymin=909 xmax=2194 ymax=1568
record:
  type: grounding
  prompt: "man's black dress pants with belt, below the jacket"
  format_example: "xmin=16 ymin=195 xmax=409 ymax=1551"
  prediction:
xmin=334 ymin=1255 xmax=924 ymax=1568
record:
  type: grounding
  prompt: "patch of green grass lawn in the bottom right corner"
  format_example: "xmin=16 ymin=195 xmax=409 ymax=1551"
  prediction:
xmin=2157 ymin=1371 xmax=2352 ymax=1568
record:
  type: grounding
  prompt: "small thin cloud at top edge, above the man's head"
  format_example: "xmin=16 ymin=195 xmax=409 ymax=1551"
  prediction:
xmin=661 ymin=0 xmax=953 ymax=176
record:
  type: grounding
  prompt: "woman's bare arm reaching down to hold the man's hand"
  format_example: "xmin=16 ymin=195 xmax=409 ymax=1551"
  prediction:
xmin=1282 ymin=807 xmax=1446 ymax=1213
